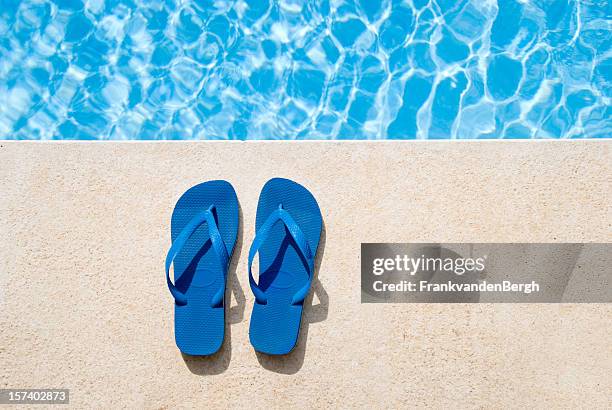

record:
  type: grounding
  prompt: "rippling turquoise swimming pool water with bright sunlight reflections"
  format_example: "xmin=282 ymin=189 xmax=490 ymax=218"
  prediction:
xmin=0 ymin=0 xmax=612 ymax=139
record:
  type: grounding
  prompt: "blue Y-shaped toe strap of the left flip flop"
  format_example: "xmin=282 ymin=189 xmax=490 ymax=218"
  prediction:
xmin=166 ymin=205 xmax=229 ymax=307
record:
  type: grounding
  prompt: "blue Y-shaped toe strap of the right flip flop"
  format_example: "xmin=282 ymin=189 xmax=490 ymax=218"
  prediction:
xmin=249 ymin=205 xmax=314 ymax=305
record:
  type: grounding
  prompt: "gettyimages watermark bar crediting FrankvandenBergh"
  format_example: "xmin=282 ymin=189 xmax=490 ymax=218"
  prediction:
xmin=361 ymin=243 xmax=612 ymax=303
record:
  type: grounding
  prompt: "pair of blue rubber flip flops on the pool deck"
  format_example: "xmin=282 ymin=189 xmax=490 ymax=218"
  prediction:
xmin=166 ymin=178 xmax=323 ymax=355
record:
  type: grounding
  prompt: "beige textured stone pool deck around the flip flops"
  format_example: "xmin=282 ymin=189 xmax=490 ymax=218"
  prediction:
xmin=0 ymin=140 xmax=612 ymax=409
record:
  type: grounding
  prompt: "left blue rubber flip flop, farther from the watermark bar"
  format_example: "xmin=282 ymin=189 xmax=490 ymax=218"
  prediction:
xmin=166 ymin=181 xmax=239 ymax=356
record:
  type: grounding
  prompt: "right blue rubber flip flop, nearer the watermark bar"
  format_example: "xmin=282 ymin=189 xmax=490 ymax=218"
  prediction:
xmin=249 ymin=178 xmax=323 ymax=355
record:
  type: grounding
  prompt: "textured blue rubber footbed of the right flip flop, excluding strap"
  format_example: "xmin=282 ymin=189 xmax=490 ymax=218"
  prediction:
xmin=249 ymin=178 xmax=323 ymax=354
